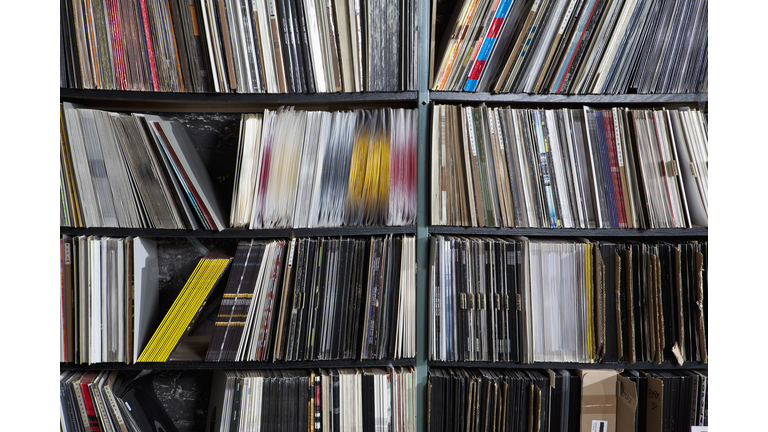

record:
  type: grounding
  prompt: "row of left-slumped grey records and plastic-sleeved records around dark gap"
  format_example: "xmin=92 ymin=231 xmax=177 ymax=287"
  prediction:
xmin=60 ymin=103 xmax=417 ymax=231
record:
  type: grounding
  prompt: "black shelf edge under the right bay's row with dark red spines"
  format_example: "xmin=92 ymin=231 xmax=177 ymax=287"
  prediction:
xmin=429 ymin=226 xmax=709 ymax=238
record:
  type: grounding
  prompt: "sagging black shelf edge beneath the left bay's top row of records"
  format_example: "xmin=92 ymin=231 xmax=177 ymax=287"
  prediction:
xmin=59 ymin=88 xmax=417 ymax=105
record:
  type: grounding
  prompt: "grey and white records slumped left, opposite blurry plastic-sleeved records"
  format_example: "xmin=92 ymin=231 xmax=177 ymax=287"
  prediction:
xmin=60 ymin=103 xmax=225 ymax=231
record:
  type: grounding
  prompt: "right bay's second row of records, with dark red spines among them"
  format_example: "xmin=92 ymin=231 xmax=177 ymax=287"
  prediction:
xmin=431 ymin=105 xmax=708 ymax=228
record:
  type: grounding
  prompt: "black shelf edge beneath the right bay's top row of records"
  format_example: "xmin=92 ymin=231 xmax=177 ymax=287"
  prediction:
xmin=429 ymin=91 xmax=709 ymax=105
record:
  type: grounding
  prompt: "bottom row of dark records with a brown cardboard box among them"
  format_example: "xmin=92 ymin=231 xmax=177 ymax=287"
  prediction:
xmin=428 ymin=368 xmax=709 ymax=432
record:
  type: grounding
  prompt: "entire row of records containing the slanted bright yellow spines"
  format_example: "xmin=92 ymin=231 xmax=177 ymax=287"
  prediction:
xmin=60 ymin=235 xmax=416 ymax=364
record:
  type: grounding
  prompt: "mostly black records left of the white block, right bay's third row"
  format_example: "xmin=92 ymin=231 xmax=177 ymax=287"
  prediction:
xmin=429 ymin=236 xmax=527 ymax=362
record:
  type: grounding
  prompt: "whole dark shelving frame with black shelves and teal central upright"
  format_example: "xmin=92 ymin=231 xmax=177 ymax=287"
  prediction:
xmin=60 ymin=0 xmax=708 ymax=432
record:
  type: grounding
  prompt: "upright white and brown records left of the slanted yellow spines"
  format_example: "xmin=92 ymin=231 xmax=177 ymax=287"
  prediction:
xmin=59 ymin=236 xmax=160 ymax=364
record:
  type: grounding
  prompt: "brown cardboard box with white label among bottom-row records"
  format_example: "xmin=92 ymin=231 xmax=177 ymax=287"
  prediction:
xmin=579 ymin=370 xmax=618 ymax=432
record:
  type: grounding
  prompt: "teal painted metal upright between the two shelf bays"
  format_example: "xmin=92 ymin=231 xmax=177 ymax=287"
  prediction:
xmin=415 ymin=0 xmax=432 ymax=432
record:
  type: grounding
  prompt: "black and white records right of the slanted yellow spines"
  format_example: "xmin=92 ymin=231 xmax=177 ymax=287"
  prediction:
xmin=205 ymin=235 xmax=416 ymax=362
